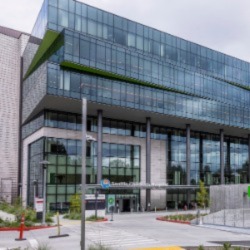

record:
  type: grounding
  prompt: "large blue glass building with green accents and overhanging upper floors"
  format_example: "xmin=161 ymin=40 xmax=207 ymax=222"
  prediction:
xmin=22 ymin=0 xmax=250 ymax=211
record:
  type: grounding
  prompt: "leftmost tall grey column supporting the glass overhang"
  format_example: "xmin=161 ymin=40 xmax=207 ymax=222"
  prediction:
xmin=97 ymin=110 xmax=103 ymax=184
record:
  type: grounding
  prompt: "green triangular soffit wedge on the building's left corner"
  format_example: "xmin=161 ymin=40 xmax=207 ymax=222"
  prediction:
xmin=24 ymin=30 xmax=62 ymax=79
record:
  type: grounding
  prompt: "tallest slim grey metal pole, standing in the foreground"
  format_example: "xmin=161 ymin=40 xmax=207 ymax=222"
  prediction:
xmin=80 ymin=98 xmax=95 ymax=250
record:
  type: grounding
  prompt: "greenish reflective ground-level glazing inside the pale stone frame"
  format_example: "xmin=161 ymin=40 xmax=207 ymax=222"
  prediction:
xmin=28 ymin=138 xmax=140 ymax=212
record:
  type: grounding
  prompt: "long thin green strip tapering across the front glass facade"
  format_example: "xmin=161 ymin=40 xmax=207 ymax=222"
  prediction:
xmin=60 ymin=61 xmax=193 ymax=97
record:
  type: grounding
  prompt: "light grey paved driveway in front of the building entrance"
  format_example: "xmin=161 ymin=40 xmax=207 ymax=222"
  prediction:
xmin=0 ymin=212 xmax=250 ymax=250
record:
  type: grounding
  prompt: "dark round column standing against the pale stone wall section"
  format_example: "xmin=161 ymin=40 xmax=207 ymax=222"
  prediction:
xmin=146 ymin=118 xmax=151 ymax=211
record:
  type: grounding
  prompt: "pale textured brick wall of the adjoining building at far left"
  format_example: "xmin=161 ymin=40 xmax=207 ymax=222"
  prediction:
xmin=0 ymin=34 xmax=28 ymax=201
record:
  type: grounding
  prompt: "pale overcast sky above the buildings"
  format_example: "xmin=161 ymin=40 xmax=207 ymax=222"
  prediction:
xmin=0 ymin=0 xmax=250 ymax=62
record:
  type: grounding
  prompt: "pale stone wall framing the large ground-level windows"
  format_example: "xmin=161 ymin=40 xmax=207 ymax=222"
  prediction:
xmin=22 ymin=127 xmax=166 ymax=209
